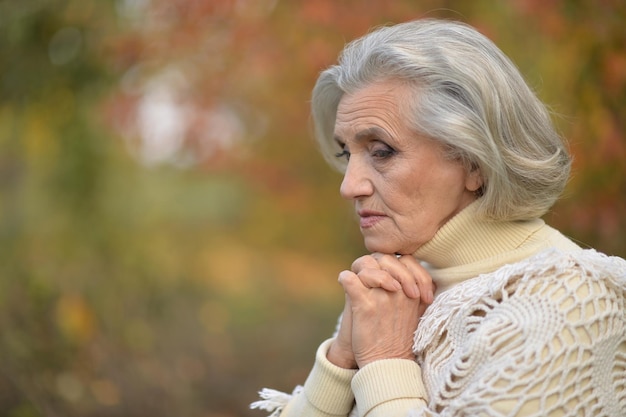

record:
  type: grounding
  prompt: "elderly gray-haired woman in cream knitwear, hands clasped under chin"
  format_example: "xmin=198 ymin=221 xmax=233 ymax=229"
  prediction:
xmin=252 ymin=20 xmax=626 ymax=417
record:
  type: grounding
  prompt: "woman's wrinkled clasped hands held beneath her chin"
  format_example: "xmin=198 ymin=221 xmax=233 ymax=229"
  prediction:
xmin=327 ymin=253 xmax=434 ymax=368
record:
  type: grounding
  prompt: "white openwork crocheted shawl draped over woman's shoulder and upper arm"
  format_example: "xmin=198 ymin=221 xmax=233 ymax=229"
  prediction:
xmin=414 ymin=250 xmax=626 ymax=417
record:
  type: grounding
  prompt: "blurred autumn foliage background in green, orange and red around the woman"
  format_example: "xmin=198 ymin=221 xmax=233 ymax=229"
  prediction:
xmin=0 ymin=0 xmax=626 ymax=417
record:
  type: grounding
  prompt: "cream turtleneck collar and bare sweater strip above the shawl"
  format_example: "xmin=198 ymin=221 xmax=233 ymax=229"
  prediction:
xmin=414 ymin=200 xmax=576 ymax=292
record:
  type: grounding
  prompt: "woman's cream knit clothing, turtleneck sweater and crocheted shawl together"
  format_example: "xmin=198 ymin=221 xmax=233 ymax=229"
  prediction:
xmin=252 ymin=203 xmax=626 ymax=417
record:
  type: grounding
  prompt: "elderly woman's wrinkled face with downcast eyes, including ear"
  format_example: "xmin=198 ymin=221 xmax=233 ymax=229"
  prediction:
xmin=335 ymin=81 xmax=482 ymax=254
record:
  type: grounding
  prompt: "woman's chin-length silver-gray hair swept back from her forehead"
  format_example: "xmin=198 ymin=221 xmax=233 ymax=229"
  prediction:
xmin=312 ymin=19 xmax=571 ymax=220
